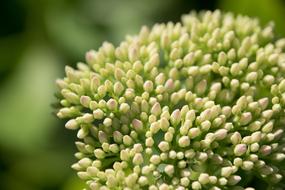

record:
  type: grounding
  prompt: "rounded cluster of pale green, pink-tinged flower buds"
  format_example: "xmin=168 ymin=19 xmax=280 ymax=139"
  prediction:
xmin=57 ymin=10 xmax=285 ymax=190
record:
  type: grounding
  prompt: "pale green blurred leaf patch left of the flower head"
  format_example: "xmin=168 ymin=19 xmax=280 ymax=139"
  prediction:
xmin=0 ymin=46 xmax=59 ymax=151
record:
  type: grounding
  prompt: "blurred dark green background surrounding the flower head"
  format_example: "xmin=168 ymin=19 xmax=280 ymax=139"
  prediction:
xmin=0 ymin=0 xmax=285 ymax=190
